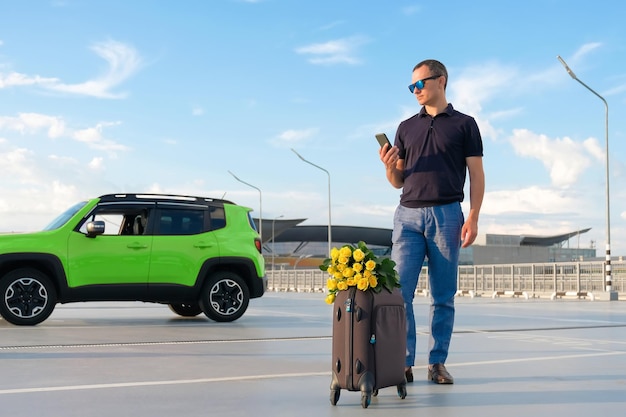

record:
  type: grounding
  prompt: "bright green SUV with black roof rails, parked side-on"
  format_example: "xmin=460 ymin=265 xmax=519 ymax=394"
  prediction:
xmin=0 ymin=194 xmax=267 ymax=325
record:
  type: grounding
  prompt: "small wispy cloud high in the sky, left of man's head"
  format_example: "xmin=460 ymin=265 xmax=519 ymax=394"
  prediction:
xmin=296 ymin=36 xmax=367 ymax=65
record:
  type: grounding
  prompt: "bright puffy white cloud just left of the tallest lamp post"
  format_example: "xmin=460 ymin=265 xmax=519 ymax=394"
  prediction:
xmin=509 ymin=129 xmax=602 ymax=187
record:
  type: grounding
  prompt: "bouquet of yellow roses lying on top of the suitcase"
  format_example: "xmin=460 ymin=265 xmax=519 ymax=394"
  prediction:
xmin=320 ymin=241 xmax=400 ymax=304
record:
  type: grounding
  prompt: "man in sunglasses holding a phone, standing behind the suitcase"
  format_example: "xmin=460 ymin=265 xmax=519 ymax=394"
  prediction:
xmin=380 ymin=59 xmax=485 ymax=384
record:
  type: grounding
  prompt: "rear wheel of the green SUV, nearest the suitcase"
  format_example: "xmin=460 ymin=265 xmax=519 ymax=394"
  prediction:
xmin=200 ymin=271 xmax=250 ymax=322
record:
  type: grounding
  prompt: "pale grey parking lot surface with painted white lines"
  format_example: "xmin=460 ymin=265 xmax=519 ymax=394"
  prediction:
xmin=0 ymin=292 xmax=626 ymax=417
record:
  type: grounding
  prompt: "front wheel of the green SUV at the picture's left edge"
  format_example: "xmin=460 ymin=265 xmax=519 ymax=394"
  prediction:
xmin=0 ymin=268 xmax=57 ymax=326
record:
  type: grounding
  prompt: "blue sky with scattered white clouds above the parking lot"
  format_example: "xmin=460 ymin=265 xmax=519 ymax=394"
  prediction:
xmin=0 ymin=0 xmax=626 ymax=257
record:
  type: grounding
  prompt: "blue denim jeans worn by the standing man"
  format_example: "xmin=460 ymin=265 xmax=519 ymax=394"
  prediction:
xmin=391 ymin=203 xmax=464 ymax=367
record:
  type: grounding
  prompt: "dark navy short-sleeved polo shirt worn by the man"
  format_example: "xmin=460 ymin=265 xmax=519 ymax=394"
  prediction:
xmin=394 ymin=104 xmax=483 ymax=208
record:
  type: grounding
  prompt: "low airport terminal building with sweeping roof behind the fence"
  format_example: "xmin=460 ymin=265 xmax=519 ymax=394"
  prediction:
xmin=255 ymin=219 xmax=597 ymax=267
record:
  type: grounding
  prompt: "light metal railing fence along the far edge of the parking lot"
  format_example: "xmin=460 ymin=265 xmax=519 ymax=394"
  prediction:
xmin=267 ymin=261 xmax=626 ymax=299
